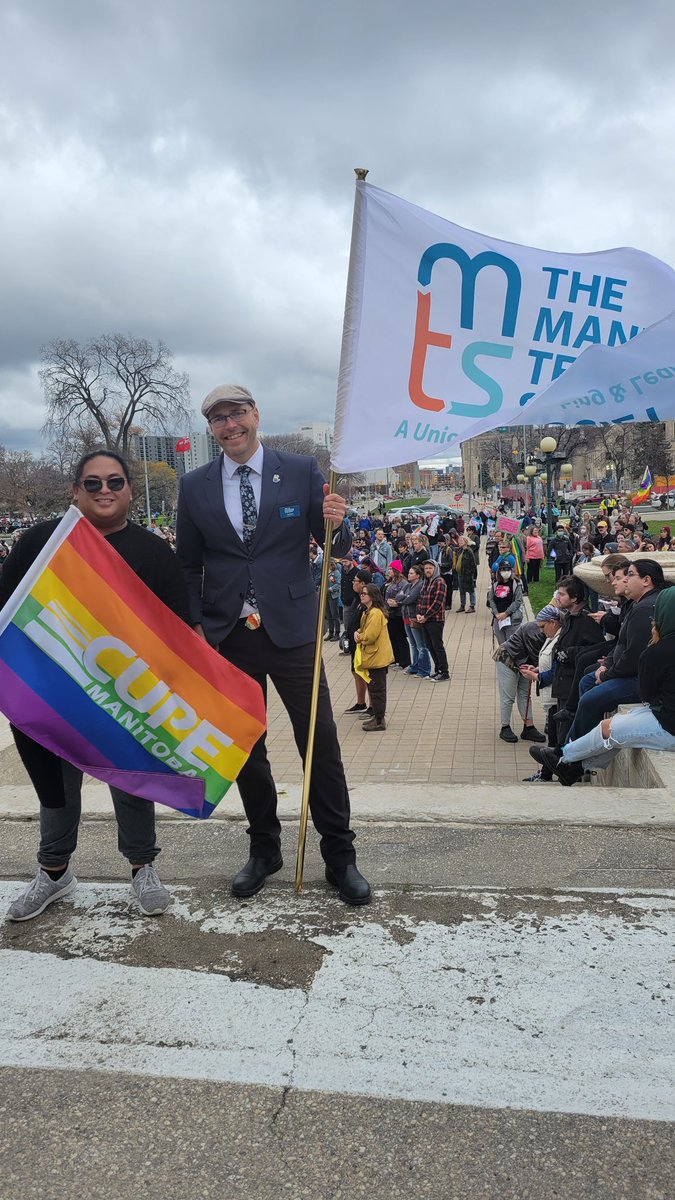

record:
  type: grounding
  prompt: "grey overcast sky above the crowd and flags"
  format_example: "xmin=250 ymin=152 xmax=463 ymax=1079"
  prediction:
xmin=0 ymin=0 xmax=675 ymax=450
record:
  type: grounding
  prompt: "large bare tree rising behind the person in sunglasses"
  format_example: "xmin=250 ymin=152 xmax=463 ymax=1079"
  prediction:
xmin=40 ymin=334 xmax=191 ymax=455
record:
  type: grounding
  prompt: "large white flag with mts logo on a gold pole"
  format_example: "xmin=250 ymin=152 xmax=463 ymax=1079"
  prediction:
xmin=331 ymin=181 xmax=675 ymax=472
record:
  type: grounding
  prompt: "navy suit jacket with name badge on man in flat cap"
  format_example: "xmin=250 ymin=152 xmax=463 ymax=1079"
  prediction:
xmin=175 ymin=449 xmax=352 ymax=647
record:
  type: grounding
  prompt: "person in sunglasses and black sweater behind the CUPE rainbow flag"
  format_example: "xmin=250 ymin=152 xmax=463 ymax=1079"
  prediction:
xmin=0 ymin=450 xmax=190 ymax=920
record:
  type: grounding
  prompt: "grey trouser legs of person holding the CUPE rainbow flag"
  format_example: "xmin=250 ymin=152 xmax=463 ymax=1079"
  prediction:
xmin=37 ymin=756 xmax=160 ymax=866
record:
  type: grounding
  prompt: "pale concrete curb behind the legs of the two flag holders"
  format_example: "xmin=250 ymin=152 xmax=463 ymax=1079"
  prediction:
xmin=0 ymin=781 xmax=675 ymax=828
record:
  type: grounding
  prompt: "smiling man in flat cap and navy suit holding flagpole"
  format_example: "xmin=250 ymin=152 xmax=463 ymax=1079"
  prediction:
xmin=177 ymin=384 xmax=370 ymax=905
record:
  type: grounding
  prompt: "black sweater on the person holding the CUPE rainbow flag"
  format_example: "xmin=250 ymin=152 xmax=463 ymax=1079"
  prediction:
xmin=0 ymin=521 xmax=190 ymax=624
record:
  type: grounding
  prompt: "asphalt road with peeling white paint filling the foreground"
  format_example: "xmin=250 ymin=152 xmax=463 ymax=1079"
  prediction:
xmin=0 ymin=821 xmax=675 ymax=1200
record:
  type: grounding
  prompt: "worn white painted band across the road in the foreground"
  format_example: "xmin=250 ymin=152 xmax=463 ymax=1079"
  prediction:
xmin=0 ymin=883 xmax=675 ymax=1120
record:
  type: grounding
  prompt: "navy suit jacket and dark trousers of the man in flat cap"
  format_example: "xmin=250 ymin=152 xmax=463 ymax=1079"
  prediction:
xmin=177 ymin=449 xmax=356 ymax=868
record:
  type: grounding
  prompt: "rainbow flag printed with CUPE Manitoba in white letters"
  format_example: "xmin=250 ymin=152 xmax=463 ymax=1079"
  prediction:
xmin=0 ymin=508 xmax=265 ymax=817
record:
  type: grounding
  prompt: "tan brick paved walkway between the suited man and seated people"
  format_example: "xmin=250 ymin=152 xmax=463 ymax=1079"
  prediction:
xmin=268 ymin=552 xmax=543 ymax=786
